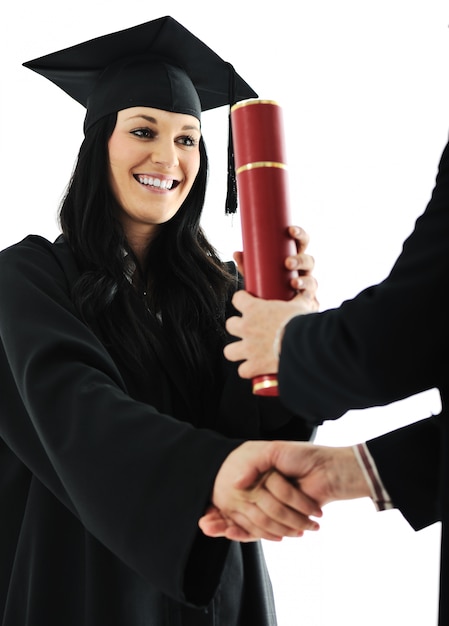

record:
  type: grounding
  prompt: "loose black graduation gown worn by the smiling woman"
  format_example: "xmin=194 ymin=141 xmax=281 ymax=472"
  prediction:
xmin=0 ymin=236 xmax=311 ymax=626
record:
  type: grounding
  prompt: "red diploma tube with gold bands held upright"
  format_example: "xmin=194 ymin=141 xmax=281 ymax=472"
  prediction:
xmin=231 ymin=100 xmax=297 ymax=396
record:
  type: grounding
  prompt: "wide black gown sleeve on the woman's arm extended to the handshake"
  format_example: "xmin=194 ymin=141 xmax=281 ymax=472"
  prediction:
xmin=0 ymin=237 xmax=240 ymax=601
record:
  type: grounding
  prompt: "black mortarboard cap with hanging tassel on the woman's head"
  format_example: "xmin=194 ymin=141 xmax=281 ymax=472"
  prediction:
xmin=24 ymin=16 xmax=257 ymax=212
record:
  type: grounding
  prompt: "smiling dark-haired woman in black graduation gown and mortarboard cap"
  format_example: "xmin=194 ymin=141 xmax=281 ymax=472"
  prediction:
xmin=0 ymin=17 xmax=315 ymax=626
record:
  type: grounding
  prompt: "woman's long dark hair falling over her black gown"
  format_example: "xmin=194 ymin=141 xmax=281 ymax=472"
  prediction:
xmin=59 ymin=114 xmax=234 ymax=384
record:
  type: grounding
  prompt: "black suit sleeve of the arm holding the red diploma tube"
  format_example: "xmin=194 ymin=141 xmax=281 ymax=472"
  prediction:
xmin=279 ymin=140 xmax=449 ymax=424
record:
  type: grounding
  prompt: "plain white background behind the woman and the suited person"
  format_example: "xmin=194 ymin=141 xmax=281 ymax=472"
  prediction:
xmin=0 ymin=0 xmax=449 ymax=626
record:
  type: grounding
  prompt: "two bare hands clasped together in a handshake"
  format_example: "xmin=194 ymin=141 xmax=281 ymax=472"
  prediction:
xmin=199 ymin=441 xmax=372 ymax=542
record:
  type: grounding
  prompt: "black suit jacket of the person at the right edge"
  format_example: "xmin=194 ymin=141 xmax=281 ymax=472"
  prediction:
xmin=279 ymin=139 xmax=449 ymax=626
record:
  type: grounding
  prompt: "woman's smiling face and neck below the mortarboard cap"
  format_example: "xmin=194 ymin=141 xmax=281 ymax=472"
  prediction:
xmin=108 ymin=107 xmax=201 ymax=256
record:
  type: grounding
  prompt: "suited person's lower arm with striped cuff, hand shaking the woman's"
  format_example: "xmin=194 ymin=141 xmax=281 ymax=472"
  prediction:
xmin=200 ymin=416 xmax=442 ymax=541
